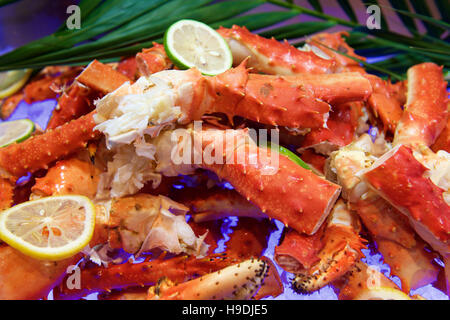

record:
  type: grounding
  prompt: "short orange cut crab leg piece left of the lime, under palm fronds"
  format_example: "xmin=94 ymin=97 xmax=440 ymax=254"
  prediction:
xmin=76 ymin=60 xmax=130 ymax=94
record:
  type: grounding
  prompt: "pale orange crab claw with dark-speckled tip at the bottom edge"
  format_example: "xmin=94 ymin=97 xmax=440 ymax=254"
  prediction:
xmin=148 ymin=259 xmax=268 ymax=300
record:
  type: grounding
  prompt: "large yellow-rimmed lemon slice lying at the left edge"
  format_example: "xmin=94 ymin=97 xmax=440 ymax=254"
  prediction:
xmin=0 ymin=195 xmax=95 ymax=260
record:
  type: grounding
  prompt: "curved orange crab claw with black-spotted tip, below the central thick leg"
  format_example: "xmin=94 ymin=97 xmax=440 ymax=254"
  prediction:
xmin=293 ymin=200 xmax=365 ymax=292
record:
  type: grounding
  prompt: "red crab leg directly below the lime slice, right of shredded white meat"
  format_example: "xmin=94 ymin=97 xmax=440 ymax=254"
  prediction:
xmin=207 ymin=63 xmax=372 ymax=128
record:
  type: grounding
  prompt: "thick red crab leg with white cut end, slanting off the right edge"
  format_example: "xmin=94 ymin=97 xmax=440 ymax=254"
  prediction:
xmin=363 ymin=145 xmax=450 ymax=256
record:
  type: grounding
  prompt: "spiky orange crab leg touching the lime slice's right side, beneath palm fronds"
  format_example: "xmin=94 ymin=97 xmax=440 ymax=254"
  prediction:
xmin=217 ymin=25 xmax=334 ymax=75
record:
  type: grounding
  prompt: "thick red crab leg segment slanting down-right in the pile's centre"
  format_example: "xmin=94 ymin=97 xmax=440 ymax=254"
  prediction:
xmin=201 ymin=130 xmax=341 ymax=234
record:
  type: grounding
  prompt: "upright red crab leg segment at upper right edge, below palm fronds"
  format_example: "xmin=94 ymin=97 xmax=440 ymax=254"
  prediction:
xmin=394 ymin=63 xmax=448 ymax=146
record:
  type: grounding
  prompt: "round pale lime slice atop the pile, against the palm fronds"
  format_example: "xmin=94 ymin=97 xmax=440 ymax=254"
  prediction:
xmin=164 ymin=20 xmax=233 ymax=76
